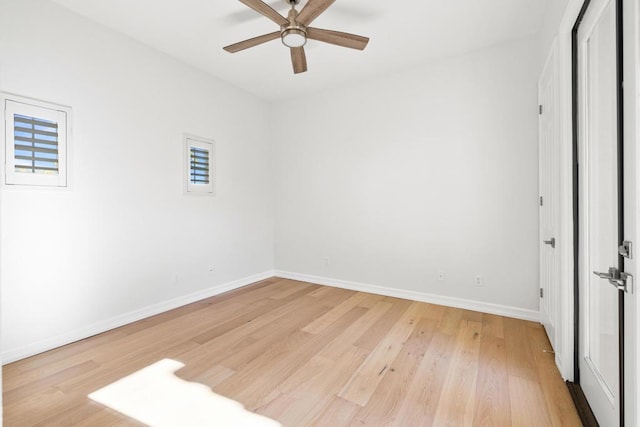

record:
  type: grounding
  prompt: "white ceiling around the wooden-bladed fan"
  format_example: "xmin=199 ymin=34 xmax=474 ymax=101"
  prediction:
xmin=51 ymin=0 xmax=553 ymax=100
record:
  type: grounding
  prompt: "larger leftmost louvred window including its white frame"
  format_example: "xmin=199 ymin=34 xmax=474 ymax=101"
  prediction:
xmin=2 ymin=94 xmax=70 ymax=187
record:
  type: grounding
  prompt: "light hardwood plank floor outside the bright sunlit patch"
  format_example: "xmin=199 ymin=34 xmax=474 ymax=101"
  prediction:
xmin=3 ymin=278 xmax=581 ymax=427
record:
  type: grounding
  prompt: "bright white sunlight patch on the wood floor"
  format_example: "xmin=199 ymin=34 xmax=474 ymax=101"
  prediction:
xmin=89 ymin=359 xmax=281 ymax=427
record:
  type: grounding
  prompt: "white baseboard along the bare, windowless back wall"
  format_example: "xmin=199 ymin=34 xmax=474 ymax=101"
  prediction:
xmin=274 ymin=270 xmax=540 ymax=322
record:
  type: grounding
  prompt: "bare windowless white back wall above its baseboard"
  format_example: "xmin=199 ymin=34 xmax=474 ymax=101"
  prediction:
xmin=273 ymin=38 xmax=540 ymax=311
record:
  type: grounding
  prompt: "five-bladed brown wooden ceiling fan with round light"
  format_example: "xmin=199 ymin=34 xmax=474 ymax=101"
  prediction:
xmin=223 ymin=0 xmax=369 ymax=74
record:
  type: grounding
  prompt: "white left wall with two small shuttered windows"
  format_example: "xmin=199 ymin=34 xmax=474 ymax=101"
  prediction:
xmin=0 ymin=0 xmax=273 ymax=363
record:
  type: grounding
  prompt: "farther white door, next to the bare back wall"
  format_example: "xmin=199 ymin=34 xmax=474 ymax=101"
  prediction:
xmin=538 ymin=44 xmax=560 ymax=351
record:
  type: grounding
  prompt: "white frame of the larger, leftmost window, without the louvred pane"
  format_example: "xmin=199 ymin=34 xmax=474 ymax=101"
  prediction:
xmin=0 ymin=92 xmax=72 ymax=188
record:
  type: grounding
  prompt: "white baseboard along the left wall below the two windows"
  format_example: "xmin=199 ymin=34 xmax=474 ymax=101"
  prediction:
xmin=0 ymin=270 xmax=274 ymax=365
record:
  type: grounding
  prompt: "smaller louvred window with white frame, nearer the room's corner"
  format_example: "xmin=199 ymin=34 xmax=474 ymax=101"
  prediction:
xmin=185 ymin=136 xmax=215 ymax=195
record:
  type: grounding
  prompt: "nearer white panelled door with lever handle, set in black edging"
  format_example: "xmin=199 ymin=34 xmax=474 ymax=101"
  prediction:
xmin=577 ymin=0 xmax=622 ymax=427
